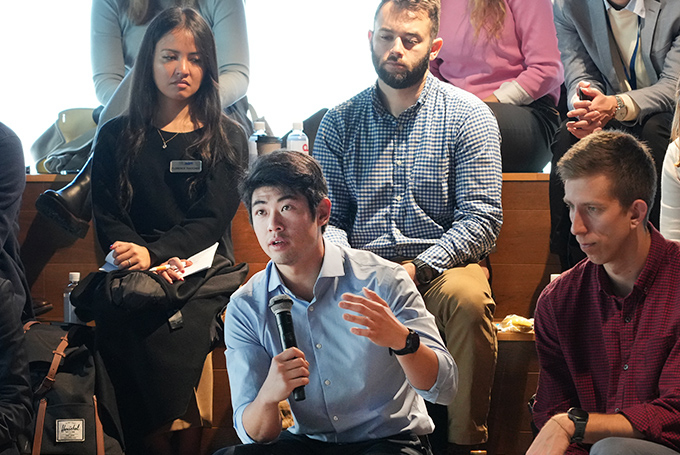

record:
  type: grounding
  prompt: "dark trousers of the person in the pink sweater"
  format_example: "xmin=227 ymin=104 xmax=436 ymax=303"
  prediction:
xmin=487 ymin=96 xmax=560 ymax=172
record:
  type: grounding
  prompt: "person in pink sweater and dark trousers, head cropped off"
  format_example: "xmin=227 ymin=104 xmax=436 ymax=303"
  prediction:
xmin=430 ymin=0 xmax=564 ymax=172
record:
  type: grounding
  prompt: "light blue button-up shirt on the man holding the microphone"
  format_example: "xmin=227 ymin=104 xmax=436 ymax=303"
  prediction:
xmin=225 ymin=242 xmax=458 ymax=443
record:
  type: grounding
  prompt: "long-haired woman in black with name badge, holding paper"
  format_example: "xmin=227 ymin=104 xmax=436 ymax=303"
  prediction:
xmin=92 ymin=8 xmax=247 ymax=454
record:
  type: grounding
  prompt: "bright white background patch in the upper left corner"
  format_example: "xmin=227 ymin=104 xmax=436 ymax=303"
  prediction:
xmin=0 ymin=0 xmax=97 ymax=164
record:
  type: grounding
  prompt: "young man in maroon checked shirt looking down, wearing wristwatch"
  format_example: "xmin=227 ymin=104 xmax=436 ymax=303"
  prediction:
xmin=527 ymin=131 xmax=680 ymax=455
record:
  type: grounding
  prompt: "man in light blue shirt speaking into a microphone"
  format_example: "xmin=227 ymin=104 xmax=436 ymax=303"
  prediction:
xmin=218 ymin=151 xmax=457 ymax=455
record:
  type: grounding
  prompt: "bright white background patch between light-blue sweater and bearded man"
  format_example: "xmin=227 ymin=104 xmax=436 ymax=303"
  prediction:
xmin=246 ymin=0 xmax=378 ymax=136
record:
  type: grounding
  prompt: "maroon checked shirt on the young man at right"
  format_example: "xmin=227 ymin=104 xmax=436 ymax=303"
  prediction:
xmin=534 ymin=224 xmax=680 ymax=453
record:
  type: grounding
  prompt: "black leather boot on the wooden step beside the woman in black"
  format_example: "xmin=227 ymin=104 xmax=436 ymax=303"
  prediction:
xmin=35 ymin=155 xmax=92 ymax=239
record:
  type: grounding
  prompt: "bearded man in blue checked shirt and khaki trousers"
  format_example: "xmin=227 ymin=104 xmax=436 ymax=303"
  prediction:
xmin=314 ymin=0 xmax=503 ymax=453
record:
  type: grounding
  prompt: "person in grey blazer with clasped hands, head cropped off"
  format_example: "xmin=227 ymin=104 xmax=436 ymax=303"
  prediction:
xmin=550 ymin=0 xmax=680 ymax=270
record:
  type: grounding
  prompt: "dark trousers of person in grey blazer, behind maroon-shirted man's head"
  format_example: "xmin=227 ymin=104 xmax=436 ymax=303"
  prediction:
xmin=550 ymin=112 xmax=673 ymax=270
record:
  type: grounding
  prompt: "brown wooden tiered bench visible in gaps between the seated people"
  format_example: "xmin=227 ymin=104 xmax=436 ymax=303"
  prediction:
xmin=20 ymin=174 xmax=559 ymax=455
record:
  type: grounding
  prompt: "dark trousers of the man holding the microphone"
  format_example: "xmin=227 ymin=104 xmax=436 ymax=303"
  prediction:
xmin=214 ymin=431 xmax=432 ymax=455
